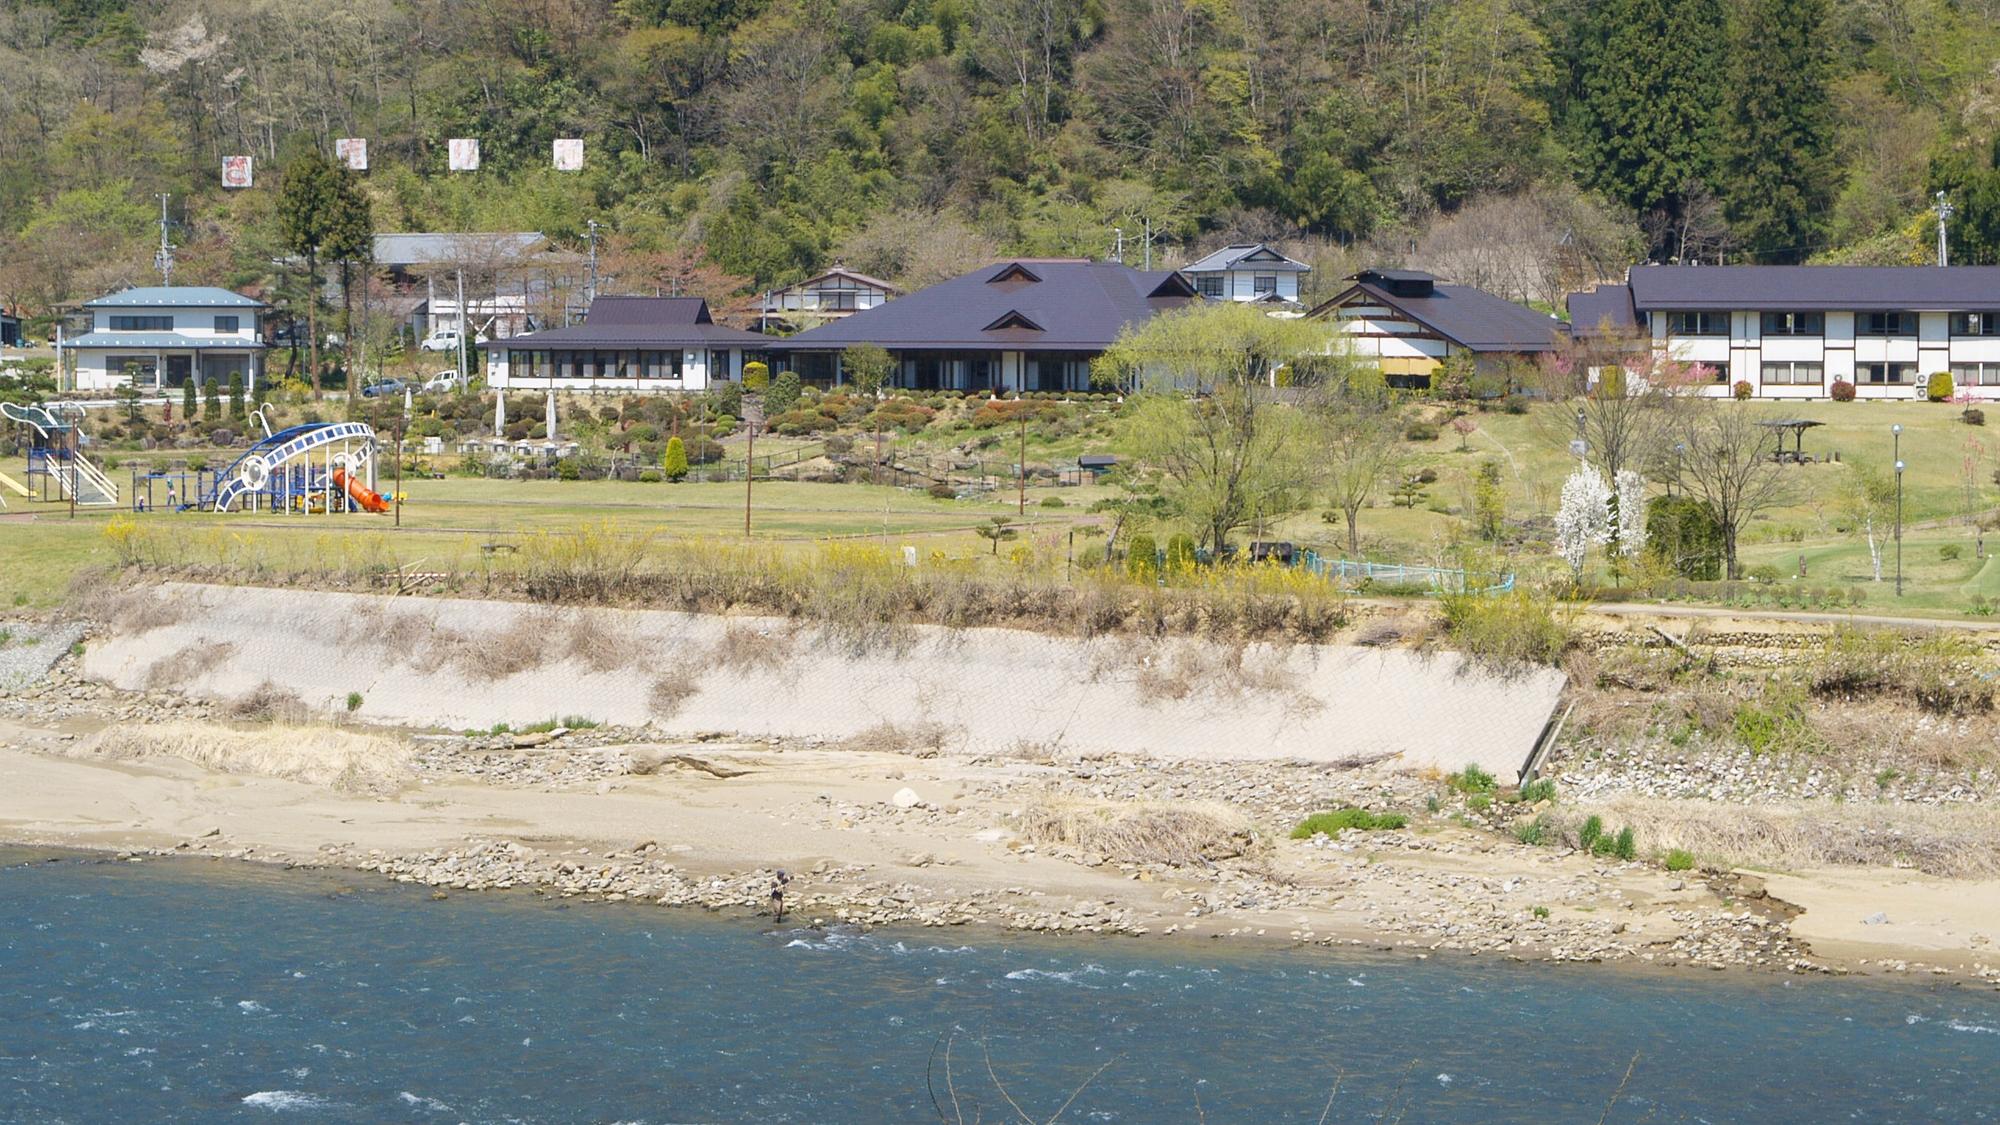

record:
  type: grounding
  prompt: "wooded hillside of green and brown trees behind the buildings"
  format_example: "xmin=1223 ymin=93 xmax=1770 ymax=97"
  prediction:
xmin=0 ymin=0 xmax=2000 ymax=324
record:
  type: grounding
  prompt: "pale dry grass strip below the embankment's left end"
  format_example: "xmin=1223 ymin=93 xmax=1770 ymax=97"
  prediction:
xmin=70 ymin=723 xmax=410 ymax=793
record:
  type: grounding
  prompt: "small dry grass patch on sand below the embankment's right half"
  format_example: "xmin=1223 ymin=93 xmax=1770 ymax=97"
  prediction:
xmin=1016 ymin=799 xmax=1250 ymax=867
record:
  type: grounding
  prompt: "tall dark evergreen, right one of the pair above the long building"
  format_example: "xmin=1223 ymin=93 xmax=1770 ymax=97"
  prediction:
xmin=1718 ymin=0 xmax=1840 ymax=262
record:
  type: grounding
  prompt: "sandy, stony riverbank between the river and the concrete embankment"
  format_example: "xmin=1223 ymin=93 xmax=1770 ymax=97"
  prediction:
xmin=0 ymin=656 xmax=2000 ymax=979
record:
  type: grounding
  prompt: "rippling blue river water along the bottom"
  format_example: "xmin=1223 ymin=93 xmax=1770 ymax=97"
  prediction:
xmin=0 ymin=849 xmax=2000 ymax=1125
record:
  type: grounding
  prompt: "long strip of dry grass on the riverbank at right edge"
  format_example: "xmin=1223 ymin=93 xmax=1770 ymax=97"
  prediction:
xmin=1552 ymin=797 xmax=2000 ymax=879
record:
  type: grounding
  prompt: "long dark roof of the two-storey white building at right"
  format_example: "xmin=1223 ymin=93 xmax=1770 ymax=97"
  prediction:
xmin=1626 ymin=266 xmax=2000 ymax=312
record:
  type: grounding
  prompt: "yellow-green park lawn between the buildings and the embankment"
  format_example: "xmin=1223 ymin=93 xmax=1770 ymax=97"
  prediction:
xmin=11 ymin=392 xmax=2000 ymax=617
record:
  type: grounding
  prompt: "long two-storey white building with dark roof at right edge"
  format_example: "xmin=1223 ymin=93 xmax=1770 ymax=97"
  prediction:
xmin=1568 ymin=266 xmax=2000 ymax=398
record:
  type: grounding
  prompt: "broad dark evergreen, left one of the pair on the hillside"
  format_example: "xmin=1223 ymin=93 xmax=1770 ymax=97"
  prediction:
xmin=1568 ymin=0 xmax=1726 ymax=254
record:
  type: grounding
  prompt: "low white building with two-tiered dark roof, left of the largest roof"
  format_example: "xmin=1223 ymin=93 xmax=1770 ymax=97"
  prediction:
xmin=480 ymin=296 xmax=770 ymax=394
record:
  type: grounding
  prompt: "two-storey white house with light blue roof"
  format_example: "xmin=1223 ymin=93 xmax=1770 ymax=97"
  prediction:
xmin=64 ymin=286 xmax=268 ymax=390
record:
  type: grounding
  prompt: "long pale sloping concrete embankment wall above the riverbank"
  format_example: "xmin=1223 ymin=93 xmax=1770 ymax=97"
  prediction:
xmin=84 ymin=583 xmax=1562 ymax=779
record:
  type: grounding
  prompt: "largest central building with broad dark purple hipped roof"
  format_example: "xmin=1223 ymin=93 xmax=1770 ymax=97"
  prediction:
xmin=772 ymin=258 xmax=1200 ymax=390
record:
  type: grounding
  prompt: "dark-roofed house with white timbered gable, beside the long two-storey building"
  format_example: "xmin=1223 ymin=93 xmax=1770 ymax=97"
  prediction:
xmin=1306 ymin=270 xmax=1568 ymax=386
